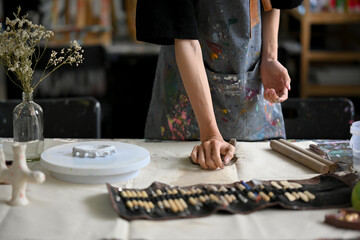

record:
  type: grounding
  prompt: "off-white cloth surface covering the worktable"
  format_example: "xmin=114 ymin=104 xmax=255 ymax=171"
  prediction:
xmin=0 ymin=139 xmax=360 ymax=240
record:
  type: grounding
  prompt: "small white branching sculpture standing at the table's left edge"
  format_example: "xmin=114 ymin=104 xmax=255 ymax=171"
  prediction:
xmin=0 ymin=142 xmax=45 ymax=206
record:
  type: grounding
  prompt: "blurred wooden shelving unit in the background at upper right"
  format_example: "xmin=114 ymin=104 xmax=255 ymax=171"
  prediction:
xmin=287 ymin=0 xmax=360 ymax=98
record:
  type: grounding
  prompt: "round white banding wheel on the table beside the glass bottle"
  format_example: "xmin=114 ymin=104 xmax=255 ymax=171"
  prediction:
xmin=40 ymin=141 xmax=150 ymax=184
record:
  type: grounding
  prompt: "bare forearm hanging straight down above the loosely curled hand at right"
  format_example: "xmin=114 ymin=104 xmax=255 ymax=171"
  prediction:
xmin=262 ymin=9 xmax=280 ymax=60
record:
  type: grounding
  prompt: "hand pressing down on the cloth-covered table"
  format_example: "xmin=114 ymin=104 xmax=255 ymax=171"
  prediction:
xmin=191 ymin=136 xmax=235 ymax=170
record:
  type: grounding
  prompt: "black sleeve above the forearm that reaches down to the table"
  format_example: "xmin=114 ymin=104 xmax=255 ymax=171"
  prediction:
xmin=136 ymin=0 xmax=198 ymax=45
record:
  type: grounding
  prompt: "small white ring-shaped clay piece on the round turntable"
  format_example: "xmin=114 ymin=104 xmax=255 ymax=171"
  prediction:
xmin=73 ymin=145 xmax=116 ymax=158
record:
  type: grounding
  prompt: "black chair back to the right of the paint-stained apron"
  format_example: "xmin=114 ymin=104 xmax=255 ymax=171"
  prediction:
xmin=281 ymin=98 xmax=355 ymax=139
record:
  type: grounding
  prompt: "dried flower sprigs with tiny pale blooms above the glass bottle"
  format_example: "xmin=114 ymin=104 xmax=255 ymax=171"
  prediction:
xmin=0 ymin=7 xmax=84 ymax=92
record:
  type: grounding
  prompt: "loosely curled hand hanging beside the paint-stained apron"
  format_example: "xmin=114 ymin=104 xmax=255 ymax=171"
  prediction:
xmin=260 ymin=59 xmax=291 ymax=103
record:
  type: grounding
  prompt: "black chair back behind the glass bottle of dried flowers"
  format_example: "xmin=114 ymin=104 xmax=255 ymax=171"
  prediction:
xmin=0 ymin=97 xmax=101 ymax=138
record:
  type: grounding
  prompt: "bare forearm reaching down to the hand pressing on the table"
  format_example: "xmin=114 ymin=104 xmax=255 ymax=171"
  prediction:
xmin=175 ymin=39 xmax=221 ymax=141
